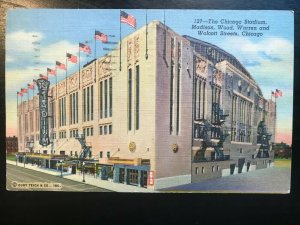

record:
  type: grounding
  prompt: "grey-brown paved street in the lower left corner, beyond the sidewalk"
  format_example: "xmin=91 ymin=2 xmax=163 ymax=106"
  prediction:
xmin=6 ymin=164 xmax=110 ymax=192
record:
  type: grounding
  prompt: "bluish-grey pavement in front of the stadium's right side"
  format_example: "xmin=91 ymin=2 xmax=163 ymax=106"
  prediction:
xmin=162 ymin=167 xmax=291 ymax=193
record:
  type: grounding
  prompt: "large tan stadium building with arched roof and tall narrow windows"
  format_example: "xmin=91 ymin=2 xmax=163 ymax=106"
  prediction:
xmin=18 ymin=21 xmax=276 ymax=190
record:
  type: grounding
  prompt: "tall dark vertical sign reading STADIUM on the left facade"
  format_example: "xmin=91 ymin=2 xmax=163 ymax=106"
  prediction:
xmin=37 ymin=79 xmax=50 ymax=146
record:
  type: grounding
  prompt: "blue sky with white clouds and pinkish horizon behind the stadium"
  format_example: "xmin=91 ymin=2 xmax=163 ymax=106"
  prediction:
xmin=6 ymin=9 xmax=294 ymax=144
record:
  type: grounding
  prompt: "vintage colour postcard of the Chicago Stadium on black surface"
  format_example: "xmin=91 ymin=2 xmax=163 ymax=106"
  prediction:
xmin=5 ymin=9 xmax=294 ymax=193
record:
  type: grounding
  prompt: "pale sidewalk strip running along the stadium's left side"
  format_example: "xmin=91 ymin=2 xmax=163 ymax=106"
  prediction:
xmin=6 ymin=160 xmax=156 ymax=193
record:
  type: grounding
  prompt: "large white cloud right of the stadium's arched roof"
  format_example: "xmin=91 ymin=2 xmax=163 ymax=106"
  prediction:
xmin=220 ymin=37 xmax=294 ymax=93
